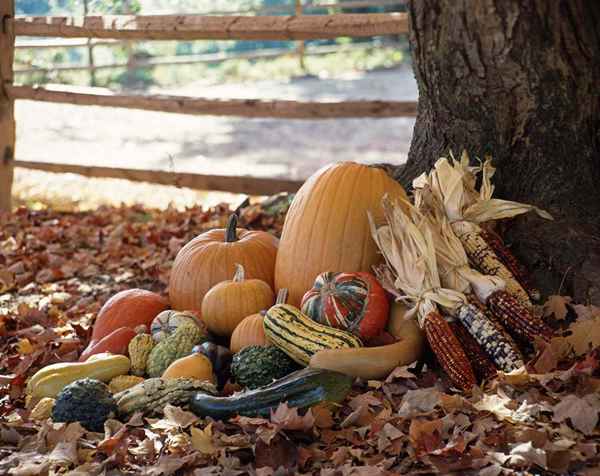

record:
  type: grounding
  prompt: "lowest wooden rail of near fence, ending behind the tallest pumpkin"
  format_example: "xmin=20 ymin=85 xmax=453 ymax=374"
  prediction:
xmin=15 ymin=160 xmax=303 ymax=195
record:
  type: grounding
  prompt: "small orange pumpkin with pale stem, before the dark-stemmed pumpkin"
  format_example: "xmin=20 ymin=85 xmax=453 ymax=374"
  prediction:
xmin=202 ymin=264 xmax=275 ymax=336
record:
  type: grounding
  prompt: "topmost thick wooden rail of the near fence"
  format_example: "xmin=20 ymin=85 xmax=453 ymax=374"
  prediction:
xmin=10 ymin=13 xmax=408 ymax=41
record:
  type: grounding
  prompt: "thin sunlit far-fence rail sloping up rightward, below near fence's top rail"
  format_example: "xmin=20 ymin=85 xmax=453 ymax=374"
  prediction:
xmin=13 ymin=43 xmax=399 ymax=74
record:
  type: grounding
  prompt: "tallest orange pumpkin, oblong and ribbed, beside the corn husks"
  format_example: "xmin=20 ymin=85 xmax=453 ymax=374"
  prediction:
xmin=275 ymin=162 xmax=407 ymax=306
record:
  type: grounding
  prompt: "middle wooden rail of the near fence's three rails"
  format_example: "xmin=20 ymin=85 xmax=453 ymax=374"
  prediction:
xmin=6 ymin=86 xmax=417 ymax=119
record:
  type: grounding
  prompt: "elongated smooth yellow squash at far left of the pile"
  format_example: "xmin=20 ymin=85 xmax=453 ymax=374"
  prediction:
xmin=27 ymin=354 xmax=130 ymax=398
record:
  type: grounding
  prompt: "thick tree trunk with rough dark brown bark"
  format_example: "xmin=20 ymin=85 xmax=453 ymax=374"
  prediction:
xmin=397 ymin=0 xmax=600 ymax=303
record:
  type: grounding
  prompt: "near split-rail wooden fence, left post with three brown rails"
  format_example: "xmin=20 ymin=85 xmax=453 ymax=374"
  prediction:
xmin=0 ymin=0 xmax=416 ymax=211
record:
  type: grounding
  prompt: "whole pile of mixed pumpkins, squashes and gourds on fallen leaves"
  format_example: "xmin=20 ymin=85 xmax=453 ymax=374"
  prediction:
xmin=27 ymin=162 xmax=454 ymax=430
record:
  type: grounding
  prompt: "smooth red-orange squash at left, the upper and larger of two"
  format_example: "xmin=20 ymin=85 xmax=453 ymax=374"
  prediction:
xmin=90 ymin=289 xmax=169 ymax=347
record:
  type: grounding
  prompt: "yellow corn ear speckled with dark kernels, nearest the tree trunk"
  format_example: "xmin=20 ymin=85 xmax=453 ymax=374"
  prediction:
xmin=452 ymin=222 xmax=532 ymax=308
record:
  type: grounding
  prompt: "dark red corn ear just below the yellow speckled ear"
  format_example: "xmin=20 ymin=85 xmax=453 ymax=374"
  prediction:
xmin=486 ymin=291 xmax=553 ymax=343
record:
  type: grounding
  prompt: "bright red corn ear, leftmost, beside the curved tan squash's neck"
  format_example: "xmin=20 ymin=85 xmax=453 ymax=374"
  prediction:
xmin=424 ymin=312 xmax=477 ymax=391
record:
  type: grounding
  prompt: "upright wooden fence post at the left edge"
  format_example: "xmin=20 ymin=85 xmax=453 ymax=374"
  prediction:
xmin=0 ymin=0 xmax=16 ymax=212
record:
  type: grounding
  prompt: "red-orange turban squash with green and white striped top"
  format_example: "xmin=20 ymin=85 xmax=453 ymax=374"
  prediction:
xmin=301 ymin=271 xmax=390 ymax=339
